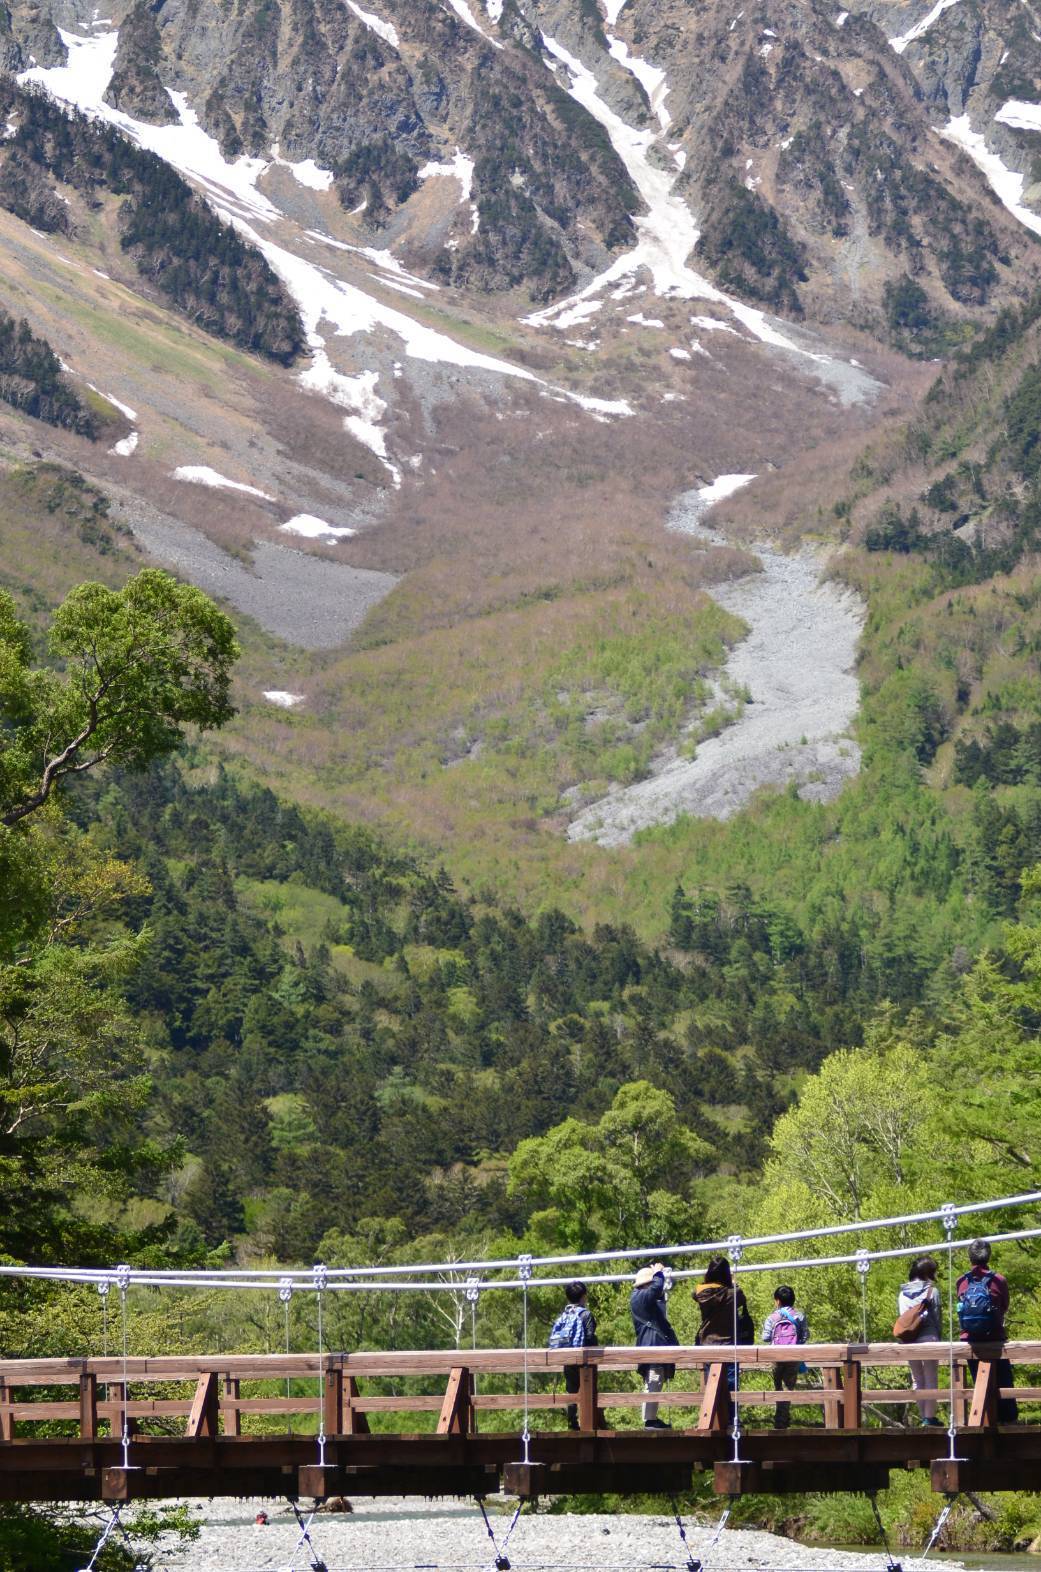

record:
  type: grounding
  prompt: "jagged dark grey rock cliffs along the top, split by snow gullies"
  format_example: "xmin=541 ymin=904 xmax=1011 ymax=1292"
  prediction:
xmin=0 ymin=0 xmax=1041 ymax=333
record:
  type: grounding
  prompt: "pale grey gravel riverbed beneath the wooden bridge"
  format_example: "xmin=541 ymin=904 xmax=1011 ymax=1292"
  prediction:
xmin=158 ymin=1498 xmax=968 ymax=1572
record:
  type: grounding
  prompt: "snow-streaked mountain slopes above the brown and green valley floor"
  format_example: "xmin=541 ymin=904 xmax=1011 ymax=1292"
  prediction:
xmin=0 ymin=0 xmax=1041 ymax=653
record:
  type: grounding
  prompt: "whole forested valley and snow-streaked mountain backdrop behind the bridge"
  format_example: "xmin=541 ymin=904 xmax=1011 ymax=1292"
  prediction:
xmin=8 ymin=0 xmax=1041 ymax=1567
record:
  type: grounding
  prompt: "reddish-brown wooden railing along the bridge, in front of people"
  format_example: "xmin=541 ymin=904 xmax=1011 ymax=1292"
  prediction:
xmin=0 ymin=1342 xmax=1041 ymax=1442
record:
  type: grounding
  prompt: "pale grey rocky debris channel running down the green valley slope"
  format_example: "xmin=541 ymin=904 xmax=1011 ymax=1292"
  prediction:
xmin=568 ymin=476 xmax=865 ymax=846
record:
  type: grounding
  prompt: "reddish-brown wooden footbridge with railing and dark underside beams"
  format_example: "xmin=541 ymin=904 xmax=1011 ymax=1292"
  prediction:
xmin=0 ymin=1342 xmax=1041 ymax=1503
